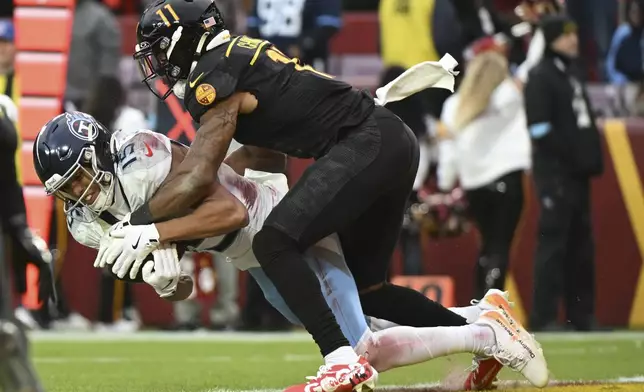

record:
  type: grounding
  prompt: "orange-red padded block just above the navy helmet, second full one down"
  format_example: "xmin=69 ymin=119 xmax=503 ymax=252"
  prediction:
xmin=16 ymin=52 xmax=67 ymax=96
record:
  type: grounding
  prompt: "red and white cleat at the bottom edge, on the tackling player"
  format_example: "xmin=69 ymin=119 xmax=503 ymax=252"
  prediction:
xmin=284 ymin=357 xmax=378 ymax=392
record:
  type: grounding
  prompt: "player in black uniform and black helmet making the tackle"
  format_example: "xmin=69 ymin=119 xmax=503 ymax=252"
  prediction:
xmin=102 ymin=0 xmax=428 ymax=392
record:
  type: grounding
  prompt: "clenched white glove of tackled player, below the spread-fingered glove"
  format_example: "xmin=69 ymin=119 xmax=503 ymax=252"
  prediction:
xmin=143 ymin=244 xmax=181 ymax=298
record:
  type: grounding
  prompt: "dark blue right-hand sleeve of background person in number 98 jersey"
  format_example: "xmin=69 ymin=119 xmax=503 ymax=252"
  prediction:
xmin=300 ymin=0 xmax=342 ymax=51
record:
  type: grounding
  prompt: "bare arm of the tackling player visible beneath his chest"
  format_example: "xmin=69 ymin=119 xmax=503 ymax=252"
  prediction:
xmin=224 ymin=146 xmax=286 ymax=176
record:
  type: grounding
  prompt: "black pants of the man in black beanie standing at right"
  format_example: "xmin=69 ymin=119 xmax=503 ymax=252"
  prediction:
xmin=530 ymin=176 xmax=595 ymax=330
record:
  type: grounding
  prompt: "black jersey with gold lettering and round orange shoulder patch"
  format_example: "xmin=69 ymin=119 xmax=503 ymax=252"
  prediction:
xmin=184 ymin=36 xmax=375 ymax=158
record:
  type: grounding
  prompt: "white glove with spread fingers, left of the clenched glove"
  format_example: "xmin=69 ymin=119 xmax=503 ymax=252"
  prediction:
xmin=94 ymin=215 xmax=159 ymax=279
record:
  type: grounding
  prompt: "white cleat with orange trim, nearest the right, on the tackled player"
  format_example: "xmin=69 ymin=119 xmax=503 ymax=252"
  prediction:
xmin=475 ymin=309 xmax=549 ymax=388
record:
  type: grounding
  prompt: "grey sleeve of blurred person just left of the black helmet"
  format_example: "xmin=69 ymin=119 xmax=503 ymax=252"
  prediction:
xmin=94 ymin=10 xmax=121 ymax=76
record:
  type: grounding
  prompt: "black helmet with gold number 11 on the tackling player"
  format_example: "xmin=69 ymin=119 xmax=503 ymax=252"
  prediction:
xmin=134 ymin=0 xmax=226 ymax=99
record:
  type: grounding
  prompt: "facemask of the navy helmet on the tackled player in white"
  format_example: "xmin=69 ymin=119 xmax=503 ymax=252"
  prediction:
xmin=45 ymin=146 xmax=115 ymax=222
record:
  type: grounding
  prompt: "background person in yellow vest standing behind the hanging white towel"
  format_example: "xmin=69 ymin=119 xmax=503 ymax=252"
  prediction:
xmin=378 ymin=0 xmax=462 ymax=275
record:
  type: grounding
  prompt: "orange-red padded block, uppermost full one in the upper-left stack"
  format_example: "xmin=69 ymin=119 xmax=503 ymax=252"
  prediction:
xmin=14 ymin=7 xmax=73 ymax=52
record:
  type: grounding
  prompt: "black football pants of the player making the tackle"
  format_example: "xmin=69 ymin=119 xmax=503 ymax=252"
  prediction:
xmin=253 ymin=107 xmax=418 ymax=355
